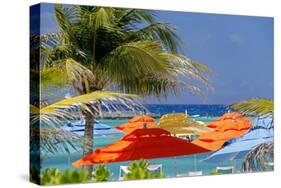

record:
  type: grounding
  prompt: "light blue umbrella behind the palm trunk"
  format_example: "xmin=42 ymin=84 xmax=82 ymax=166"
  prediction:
xmin=63 ymin=120 xmax=123 ymax=136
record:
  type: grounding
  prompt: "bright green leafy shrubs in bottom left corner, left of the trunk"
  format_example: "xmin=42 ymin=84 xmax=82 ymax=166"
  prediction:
xmin=40 ymin=168 xmax=89 ymax=185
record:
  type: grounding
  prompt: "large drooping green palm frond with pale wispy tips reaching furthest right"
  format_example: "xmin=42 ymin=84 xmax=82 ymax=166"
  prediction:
xmin=101 ymin=41 xmax=210 ymax=96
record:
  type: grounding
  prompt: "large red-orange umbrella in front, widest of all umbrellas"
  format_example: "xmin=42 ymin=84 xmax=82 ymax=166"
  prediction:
xmin=72 ymin=128 xmax=209 ymax=167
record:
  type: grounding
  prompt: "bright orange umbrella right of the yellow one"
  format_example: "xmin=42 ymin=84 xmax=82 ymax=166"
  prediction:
xmin=192 ymin=113 xmax=252 ymax=151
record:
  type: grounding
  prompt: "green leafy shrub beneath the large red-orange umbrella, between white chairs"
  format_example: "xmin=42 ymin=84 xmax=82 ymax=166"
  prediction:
xmin=124 ymin=160 xmax=165 ymax=180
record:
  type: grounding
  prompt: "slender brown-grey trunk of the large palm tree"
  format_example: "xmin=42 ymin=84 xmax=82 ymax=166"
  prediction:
xmin=83 ymin=108 xmax=94 ymax=177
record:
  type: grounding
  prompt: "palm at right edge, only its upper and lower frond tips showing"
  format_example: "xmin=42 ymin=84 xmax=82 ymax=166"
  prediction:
xmin=230 ymin=98 xmax=274 ymax=172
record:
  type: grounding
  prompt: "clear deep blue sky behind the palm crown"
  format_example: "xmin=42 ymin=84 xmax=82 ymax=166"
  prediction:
xmin=34 ymin=4 xmax=273 ymax=104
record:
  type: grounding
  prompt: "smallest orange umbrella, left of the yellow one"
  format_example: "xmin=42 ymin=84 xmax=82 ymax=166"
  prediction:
xmin=115 ymin=115 xmax=156 ymax=134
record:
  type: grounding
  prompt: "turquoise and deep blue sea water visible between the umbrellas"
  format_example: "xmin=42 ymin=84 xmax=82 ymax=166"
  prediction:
xmin=42 ymin=104 xmax=241 ymax=180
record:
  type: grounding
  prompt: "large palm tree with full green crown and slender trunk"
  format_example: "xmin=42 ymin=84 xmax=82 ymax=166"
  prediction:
xmin=41 ymin=5 xmax=211 ymax=170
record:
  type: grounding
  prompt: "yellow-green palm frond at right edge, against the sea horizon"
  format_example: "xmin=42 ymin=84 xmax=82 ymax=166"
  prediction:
xmin=230 ymin=98 xmax=274 ymax=117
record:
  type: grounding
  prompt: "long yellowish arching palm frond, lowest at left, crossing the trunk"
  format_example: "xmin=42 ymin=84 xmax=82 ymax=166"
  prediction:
xmin=31 ymin=91 xmax=144 ymax=127
